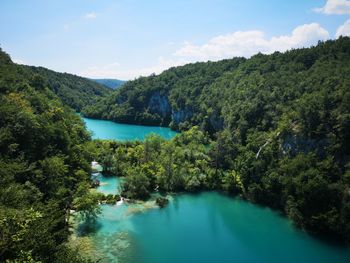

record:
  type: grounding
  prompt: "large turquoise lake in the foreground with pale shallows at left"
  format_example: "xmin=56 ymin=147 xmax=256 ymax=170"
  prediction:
xmin=76 ymin=175 xmax=350 ymax=263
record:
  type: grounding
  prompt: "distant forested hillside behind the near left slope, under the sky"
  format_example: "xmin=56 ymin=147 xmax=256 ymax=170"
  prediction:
xmin=3 ymin=53 xmax=111 ymax=111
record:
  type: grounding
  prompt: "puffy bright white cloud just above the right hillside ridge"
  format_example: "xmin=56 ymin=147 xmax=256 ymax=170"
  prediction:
xmin=175 ymin=23 xmax=329 ymax=61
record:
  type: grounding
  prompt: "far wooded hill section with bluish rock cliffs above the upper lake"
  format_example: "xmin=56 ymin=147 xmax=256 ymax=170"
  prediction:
xmin=83 ymin=58 xmax=245 ymax=127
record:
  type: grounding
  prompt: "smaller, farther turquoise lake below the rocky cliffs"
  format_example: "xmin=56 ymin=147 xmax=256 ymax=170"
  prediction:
xmin=82 ymin=118 xmax=177 ymax=141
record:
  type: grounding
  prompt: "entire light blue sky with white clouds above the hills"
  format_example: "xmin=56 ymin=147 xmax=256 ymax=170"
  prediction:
xmin=0 ymin=0 xmax=350 ymax=80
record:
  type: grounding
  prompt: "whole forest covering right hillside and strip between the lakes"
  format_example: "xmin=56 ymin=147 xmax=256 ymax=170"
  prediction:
xmin=83 ymin=37 xmax=350 ymax=242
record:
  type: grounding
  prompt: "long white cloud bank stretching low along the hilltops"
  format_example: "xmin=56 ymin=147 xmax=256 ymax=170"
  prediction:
xmin=78 ymin=23 xmax=329 ymax=80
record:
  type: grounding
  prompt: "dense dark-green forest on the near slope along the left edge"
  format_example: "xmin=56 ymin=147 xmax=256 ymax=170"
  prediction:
xmin=0 ymin=50 xmax=98 ymax=263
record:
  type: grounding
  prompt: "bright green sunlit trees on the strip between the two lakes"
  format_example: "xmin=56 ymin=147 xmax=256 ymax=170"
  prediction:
xmin=96 ymin=127 xmax=213 ymax=199
